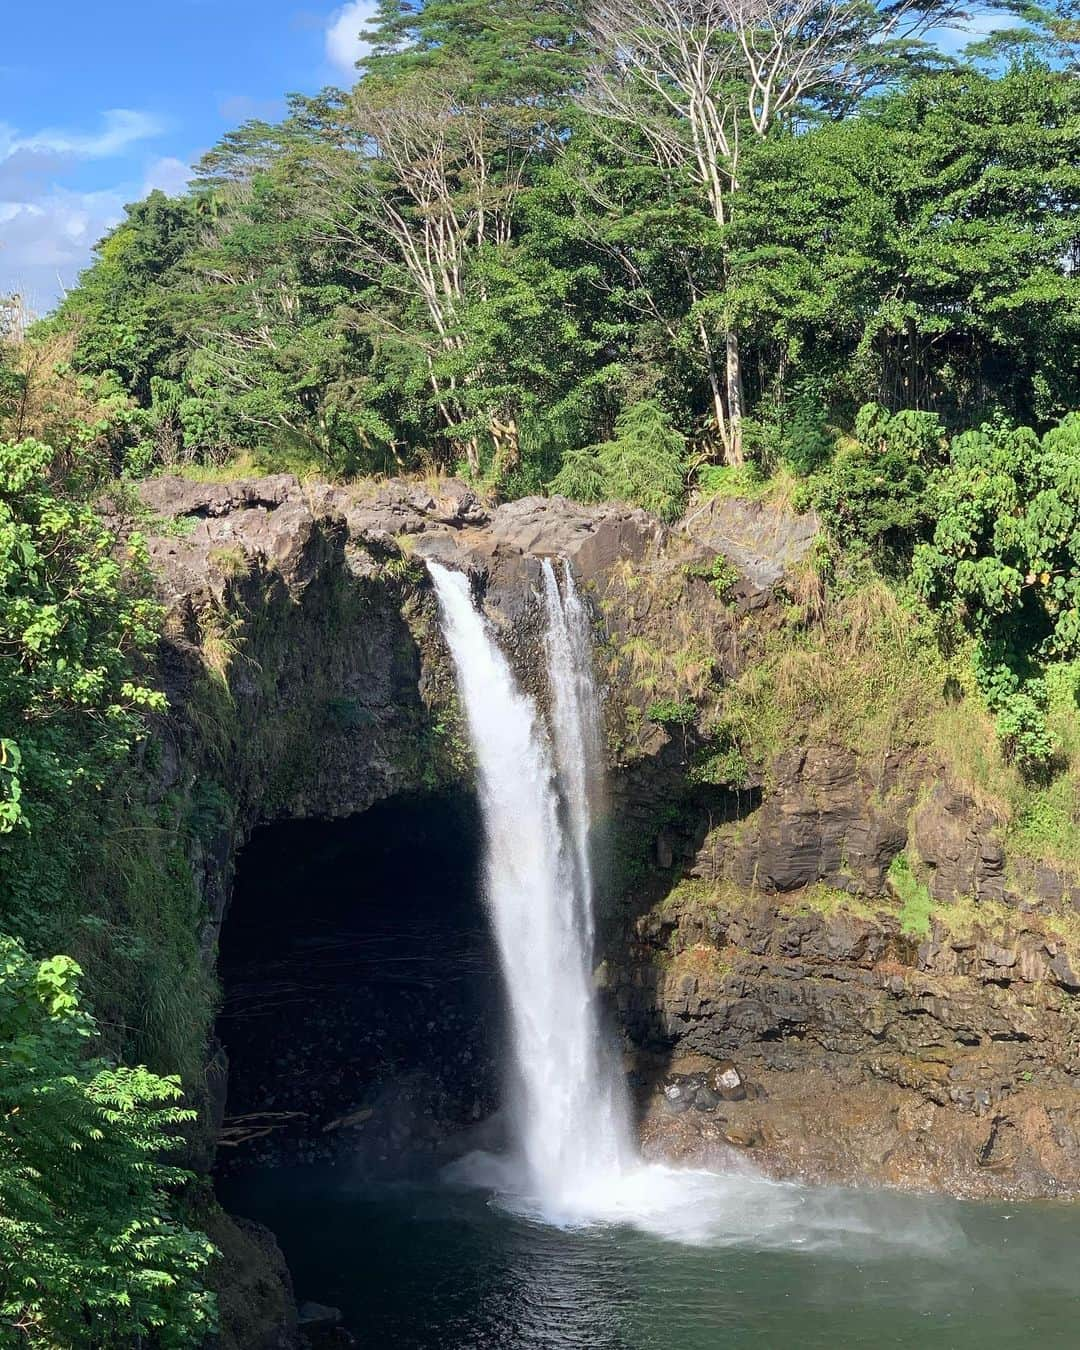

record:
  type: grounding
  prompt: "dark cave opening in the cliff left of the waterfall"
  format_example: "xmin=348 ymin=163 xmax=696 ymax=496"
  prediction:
xmin=217 ymin=795 xmax=502 ymax=1179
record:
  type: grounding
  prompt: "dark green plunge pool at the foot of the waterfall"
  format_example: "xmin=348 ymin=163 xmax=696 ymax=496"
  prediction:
xmin=223 ymin=1168 xmax=1080 ymax=1350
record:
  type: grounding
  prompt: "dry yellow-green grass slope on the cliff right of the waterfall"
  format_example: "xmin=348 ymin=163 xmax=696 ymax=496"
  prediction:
xmin=713 ymin=578 xmax=1080 ymax=867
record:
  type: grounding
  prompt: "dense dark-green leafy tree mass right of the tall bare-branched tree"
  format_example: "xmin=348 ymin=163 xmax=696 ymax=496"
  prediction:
xmin=729 ymin=61 xmax=1080 ymax=432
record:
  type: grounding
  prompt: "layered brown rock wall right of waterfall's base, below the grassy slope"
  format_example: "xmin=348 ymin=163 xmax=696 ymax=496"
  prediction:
xmin=606 ymin=747 xmax=1080 ymax=1197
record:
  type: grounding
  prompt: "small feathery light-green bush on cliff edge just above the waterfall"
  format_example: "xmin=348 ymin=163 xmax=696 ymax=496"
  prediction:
xmin=549 ymin=398 xmax=686 ymax=520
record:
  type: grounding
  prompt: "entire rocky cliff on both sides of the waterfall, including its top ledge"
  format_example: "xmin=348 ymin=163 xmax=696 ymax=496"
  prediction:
xmin=132 ymin=475 xmax=1080 ymax=1346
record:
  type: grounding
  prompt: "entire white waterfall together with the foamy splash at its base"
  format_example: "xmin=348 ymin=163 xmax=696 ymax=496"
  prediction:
xmin=388 ymin=563 xmax=972 ymax=1258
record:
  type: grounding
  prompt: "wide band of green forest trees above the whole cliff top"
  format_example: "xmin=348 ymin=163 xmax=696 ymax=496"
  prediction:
xmin=35 ymin=35 xmax=1080 ymax=496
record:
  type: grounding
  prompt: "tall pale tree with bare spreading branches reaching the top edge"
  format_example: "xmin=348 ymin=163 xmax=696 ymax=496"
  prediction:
xmin=587 ymin=0 xmax=954 ymax=463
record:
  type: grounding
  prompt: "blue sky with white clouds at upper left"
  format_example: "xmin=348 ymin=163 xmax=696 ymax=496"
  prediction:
xmin=0 ymin=0 xmax=979 ymax=313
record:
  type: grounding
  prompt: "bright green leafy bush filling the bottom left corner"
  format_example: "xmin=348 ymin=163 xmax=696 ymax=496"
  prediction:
xmin=0 ymin=936 xmax=215 ymax=1350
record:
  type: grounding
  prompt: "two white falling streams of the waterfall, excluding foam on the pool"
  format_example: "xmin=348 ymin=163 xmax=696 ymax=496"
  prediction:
xmin=428 ymin=562 xmax=633 ymax=1218
